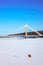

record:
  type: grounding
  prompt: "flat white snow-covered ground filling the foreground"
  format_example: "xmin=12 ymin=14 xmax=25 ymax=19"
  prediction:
xmin=0 ymin=38 xmax=43 ymax=65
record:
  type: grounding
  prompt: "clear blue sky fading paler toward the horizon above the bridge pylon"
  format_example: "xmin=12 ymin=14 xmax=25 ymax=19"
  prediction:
xmin=0 ymin=0 xmax=43 ymax=35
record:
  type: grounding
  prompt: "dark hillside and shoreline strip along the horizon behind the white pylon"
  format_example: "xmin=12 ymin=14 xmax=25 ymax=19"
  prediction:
xmin=0 ymin=31 xmax=43 ymax=38
